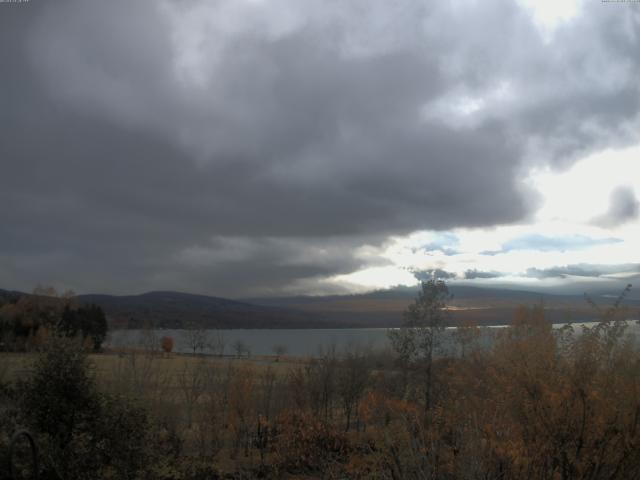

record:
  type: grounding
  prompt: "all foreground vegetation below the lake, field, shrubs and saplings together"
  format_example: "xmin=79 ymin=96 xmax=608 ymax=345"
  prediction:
xmin=0 ymin=282 xmax=640 ymax=480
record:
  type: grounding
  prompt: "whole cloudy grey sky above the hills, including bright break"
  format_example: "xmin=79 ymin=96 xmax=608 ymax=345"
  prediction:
xmin=0 ymin=0 xmax=640 ymax=298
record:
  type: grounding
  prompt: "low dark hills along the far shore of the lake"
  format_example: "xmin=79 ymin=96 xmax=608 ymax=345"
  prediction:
xmin=0 ymin=285 xmax=640 ymax=329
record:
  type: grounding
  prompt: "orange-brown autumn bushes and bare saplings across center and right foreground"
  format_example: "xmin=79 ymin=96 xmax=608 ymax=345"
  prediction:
xmin=5 ymin=288 xmax=640 ymax=480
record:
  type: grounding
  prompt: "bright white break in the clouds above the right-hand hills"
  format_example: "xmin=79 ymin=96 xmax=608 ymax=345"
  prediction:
xmin=342 ymin=145 xmax=640 ymax=291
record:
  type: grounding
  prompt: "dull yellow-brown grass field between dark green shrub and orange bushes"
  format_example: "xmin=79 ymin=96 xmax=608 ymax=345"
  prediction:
xmin=0 ymin=351 xmax=316 ymax=478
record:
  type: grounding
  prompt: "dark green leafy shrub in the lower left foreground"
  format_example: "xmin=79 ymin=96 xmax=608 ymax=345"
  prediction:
xmin=17 ymin=337 xmax=149 ymax=480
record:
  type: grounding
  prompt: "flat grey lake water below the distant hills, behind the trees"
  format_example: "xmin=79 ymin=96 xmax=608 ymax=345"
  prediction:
xmin=105 ymin=321 xmax=640 ymax=356
